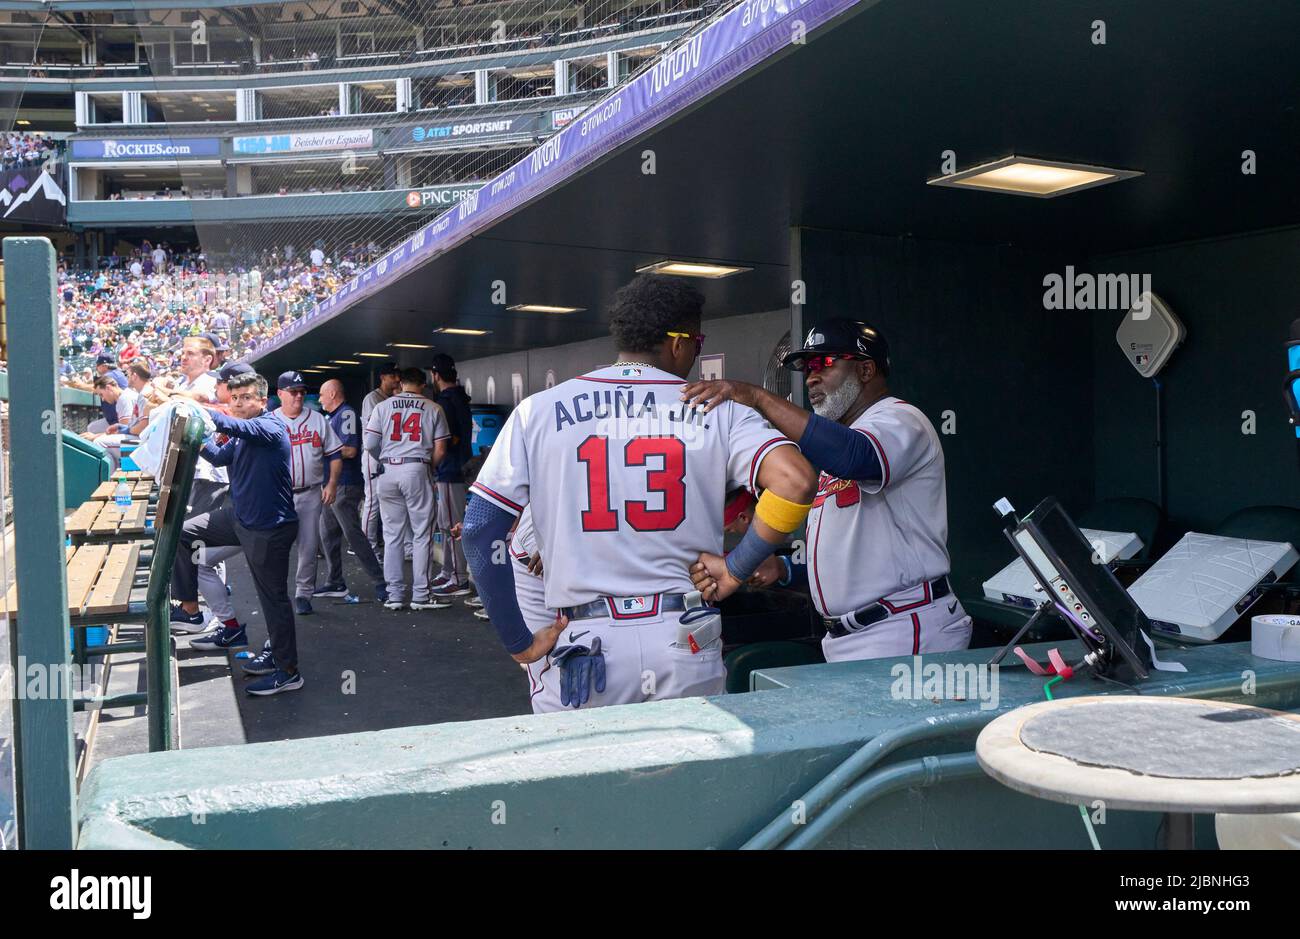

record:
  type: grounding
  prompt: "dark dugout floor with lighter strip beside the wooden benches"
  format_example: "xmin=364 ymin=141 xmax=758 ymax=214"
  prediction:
xmin=91 ymin=546 xmax=530 ymax=765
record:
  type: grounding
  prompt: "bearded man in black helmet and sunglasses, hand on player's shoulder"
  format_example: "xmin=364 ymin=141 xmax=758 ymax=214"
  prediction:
xmin=683 ymin=319 xmax=971 ymax=662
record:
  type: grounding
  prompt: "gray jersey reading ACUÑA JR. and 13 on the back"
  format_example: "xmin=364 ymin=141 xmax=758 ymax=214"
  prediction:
xmin=472 ymin=365 xmax=793 ymax=609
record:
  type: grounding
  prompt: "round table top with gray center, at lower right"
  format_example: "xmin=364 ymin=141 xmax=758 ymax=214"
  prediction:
xmin=975 ymin=694 xmax=1300 ymax=814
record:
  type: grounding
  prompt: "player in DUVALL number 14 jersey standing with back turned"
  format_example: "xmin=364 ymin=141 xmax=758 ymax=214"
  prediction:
xmin=365 ymin=368 xmax=451 ymax=610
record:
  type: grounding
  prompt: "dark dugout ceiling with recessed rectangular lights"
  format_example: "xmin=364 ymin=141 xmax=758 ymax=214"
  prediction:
xmin=250 ymin=0 xmax=1300 ymax=375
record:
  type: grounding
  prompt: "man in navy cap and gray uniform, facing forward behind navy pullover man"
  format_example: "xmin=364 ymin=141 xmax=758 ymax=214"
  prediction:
xmin=270 ymin=372 xmax=343 ymax=616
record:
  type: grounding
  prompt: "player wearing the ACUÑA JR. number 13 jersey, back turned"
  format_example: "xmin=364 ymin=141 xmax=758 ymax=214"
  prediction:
xmin=463 ymin=274 xmax=816 ymax=711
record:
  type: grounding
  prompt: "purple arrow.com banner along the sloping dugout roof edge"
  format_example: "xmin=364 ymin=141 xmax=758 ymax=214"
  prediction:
xmin=260 ymin=0 xmax=874 ymax=355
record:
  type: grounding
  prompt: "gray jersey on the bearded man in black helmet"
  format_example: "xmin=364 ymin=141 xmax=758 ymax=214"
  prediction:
xmin=807 ymin=397 xmax=949 ymax=616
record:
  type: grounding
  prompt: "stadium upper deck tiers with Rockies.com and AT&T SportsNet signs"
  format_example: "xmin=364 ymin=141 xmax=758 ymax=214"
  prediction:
xmin=0 ymin=0 xmax=716 ymax=252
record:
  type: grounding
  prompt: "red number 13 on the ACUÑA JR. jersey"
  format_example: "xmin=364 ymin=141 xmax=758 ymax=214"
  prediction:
xmin=577 ymin=434 xmax=686 ymax=532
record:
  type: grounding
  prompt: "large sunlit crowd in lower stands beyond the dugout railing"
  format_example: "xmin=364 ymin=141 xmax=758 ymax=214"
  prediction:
xmin=59 ymin=242 xmax=378 ymax=385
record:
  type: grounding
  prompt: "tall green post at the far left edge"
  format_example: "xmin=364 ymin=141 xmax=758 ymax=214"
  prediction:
xmin=4 ymin=238 xmax=77 ymax=849
